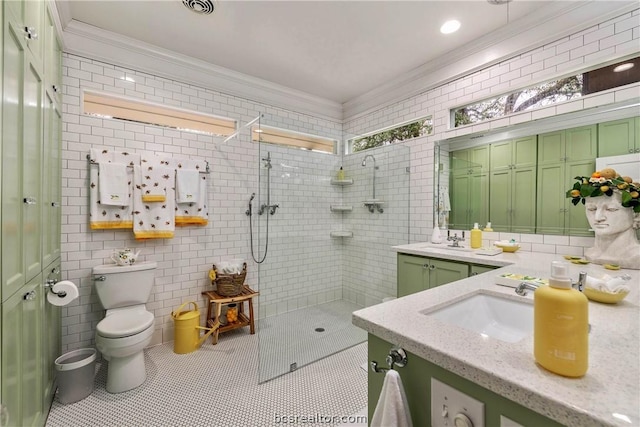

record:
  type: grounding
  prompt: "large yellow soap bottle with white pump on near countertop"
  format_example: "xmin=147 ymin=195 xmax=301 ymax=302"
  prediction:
xmin=533 ymin=261 xmax=589 ymax=377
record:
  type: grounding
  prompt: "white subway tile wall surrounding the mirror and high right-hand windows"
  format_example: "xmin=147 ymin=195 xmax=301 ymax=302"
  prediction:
xmin=344 ymin=9 xmax=640 ymax=247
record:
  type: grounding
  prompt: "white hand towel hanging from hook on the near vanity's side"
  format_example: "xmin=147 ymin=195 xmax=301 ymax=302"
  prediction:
xmin=371 ymin=369 xmax=413 ymax=427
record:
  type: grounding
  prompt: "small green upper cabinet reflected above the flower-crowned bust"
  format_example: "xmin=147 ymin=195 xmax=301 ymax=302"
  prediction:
xmin=598 ymin=117 xmax=640 ymax=157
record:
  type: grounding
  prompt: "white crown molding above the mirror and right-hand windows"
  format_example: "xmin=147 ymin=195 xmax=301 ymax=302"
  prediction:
xmin=343 ymin=1 xmax=638 ymax=122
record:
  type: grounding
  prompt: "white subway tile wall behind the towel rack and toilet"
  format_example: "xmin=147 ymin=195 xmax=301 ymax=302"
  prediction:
xmin=62 ymin=54 xmax=341 ymax=351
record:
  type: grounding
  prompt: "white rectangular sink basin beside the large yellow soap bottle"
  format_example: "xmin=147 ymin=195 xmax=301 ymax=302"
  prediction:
xmin=423 ymin=294 xmax=533 ymax=342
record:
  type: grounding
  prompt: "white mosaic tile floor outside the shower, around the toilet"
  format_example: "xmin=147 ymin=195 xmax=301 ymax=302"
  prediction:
xmin=46 ymin=318 xmax=367 ymax=427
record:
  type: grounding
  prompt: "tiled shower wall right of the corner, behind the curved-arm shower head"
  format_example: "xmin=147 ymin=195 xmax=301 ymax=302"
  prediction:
xmin=338 ymin=144 xmax=411 ymax=306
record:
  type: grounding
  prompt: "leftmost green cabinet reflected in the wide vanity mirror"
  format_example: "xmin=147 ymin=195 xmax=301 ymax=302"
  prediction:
xmin=449 ymin=146 xmax=489 ymax=230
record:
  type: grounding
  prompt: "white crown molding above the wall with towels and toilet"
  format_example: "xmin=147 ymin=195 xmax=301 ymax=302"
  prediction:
xmin=58 ymin=20 xmax=342 ymax=122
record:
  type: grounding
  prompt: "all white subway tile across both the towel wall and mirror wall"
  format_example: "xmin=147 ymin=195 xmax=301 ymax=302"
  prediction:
xmin=62 ymin=10 xmax=640 ymax=351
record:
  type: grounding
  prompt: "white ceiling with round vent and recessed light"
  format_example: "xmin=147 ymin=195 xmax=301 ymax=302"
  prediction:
xmin=56 ymin=0 xmax=552 ymax=104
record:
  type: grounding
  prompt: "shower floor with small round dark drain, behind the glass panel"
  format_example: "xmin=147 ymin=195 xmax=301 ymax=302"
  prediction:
xmin=257 ymin=300 xmax=367 ymax=382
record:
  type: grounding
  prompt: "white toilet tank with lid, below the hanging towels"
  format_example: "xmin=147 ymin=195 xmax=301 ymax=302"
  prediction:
xmin=93 ymin=262 xmax=158 ymax=310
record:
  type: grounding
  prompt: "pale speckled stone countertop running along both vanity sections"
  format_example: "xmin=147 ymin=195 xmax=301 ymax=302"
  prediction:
xmin=353 ymin=243 xmax=640 ymax=427
